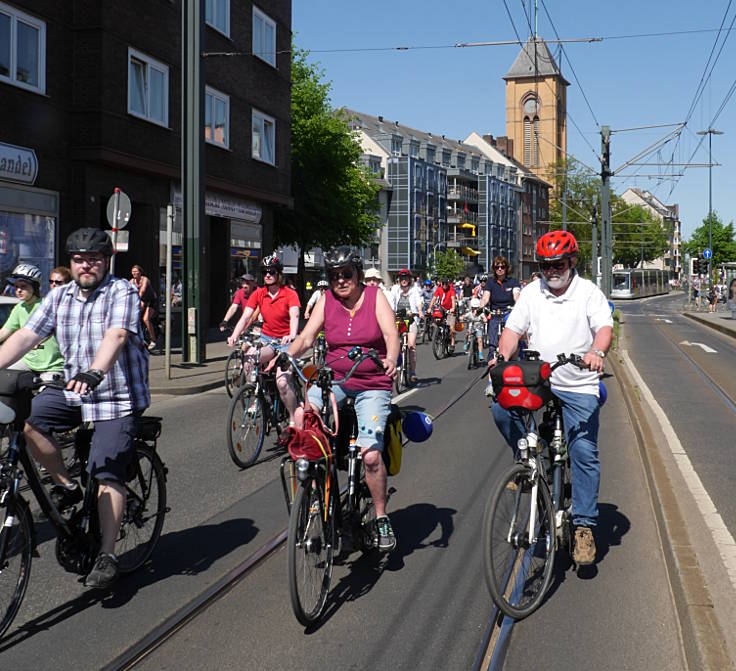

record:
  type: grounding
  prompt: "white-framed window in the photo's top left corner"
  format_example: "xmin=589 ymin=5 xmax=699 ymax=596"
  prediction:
xmin=0 ymin=2 xmax=46 ymax=93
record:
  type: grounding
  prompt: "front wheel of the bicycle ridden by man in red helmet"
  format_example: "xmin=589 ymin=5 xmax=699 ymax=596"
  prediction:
xmin=482 ymin=464 xmax=555 ymax=620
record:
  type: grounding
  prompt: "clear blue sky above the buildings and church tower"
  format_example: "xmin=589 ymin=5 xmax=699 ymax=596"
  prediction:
xmin=292 ymin=0 xmax=736 ymax=239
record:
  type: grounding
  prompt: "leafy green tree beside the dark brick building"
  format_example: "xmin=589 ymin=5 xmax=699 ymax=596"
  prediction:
xmin=274 ymin=47 xmax=380 ymax=286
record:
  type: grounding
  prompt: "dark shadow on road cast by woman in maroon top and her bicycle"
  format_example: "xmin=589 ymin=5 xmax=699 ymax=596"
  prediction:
xmin=305 ymin=503 xmax=457 ymax=634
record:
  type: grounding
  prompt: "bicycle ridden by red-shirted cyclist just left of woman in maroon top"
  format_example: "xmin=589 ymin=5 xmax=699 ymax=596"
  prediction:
xmin=226 ymin=350 xmax=303 ymax=468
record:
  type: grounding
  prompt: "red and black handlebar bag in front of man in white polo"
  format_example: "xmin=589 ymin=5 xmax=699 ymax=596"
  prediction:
xmin=491 ymin=360 xmax=553 ymax=410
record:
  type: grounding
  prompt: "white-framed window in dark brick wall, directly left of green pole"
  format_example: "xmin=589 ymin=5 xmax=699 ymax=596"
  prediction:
xmin=128 ymin=48 xmax=169 ymax=126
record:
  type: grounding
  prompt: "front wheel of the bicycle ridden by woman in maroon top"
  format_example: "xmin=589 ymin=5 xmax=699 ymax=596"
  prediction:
xmin=287 ymin=468 xmax=337 ymax=626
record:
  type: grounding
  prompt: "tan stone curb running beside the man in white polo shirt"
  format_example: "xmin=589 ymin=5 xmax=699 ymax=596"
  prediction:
xmin=611 ymin=353 xmax=734 ymax=671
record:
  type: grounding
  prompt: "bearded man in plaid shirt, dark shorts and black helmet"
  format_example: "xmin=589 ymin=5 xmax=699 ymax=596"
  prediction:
xmin=0 ymin=228 xmax=150 ymax=589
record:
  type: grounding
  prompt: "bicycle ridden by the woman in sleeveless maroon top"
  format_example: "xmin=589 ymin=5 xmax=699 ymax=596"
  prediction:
xmin=281 ymin=347 xmax=390 ymax=626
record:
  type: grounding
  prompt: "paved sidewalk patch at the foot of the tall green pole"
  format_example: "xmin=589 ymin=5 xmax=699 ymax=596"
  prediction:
xmin=148 ymin=341 xmax=232 ymax=396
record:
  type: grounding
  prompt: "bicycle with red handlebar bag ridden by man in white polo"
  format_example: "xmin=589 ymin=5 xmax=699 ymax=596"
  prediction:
xmin=482 ymin=350 xmax=596 ymax=620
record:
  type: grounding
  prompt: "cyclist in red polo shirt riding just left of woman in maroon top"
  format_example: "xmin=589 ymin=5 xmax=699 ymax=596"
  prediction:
xmin=227 ymin=254 xmax=301 ymax=426
